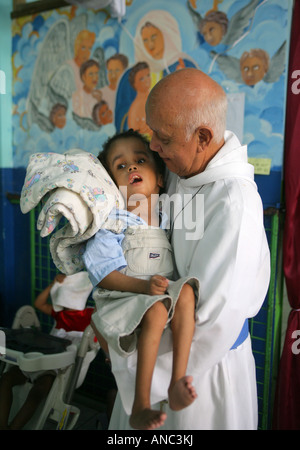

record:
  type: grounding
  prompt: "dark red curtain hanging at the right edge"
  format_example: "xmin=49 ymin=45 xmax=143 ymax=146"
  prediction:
xmin=273 ymin=0 xmax=300 ymax=430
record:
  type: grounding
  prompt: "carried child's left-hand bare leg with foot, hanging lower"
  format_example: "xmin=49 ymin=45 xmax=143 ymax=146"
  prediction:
xmin=130 ymin=302 xmax=168 ymax=430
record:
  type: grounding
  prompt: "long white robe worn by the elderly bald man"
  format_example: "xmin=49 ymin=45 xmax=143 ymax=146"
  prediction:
xmin=110 ymin=132 xmax=270 ymax=430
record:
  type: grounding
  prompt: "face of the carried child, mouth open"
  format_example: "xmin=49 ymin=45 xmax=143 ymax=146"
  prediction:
xmin=108 ymin=137 xmax=163 ymax=200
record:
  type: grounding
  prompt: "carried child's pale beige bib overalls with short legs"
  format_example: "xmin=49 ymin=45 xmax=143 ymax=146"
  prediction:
xmin=92 ymin=227 xmax=199 ymax=356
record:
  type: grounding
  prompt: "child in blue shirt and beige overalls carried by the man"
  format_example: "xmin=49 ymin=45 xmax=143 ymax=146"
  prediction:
xmin=83 ymin=130 xmax=198 ymax=429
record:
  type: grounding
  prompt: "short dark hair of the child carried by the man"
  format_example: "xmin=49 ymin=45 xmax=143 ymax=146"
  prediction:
xmin=98 ymin=128 xmax=166 ymax=190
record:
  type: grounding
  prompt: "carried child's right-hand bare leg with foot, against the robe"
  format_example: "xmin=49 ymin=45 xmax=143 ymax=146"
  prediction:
xmin=169 ymin=284 xmax=197 ymax=411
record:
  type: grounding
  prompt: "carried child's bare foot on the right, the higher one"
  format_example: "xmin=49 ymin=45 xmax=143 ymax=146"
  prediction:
xmin=169 ymin=376 xmax=197 ymax=411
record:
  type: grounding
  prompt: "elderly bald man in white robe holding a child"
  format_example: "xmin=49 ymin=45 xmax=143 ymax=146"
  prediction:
xmin=110 ymin=69 xmax=270 ymax=430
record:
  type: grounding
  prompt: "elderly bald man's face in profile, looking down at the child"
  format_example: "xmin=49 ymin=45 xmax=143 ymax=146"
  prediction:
xmin=146 ymin=105 xmax=198 ymax=177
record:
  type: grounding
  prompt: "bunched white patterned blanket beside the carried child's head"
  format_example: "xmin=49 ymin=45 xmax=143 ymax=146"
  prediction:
xmin=20 ymin=149 xmax=124 ymax=275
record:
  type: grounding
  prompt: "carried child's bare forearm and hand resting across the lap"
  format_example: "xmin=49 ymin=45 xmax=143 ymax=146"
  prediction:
xmin=98 ymin=270 xmax=169 ymax=295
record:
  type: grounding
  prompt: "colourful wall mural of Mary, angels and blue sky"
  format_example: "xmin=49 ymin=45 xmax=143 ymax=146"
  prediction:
xmin=12 ymin=0 xmax=292 ymax=201
